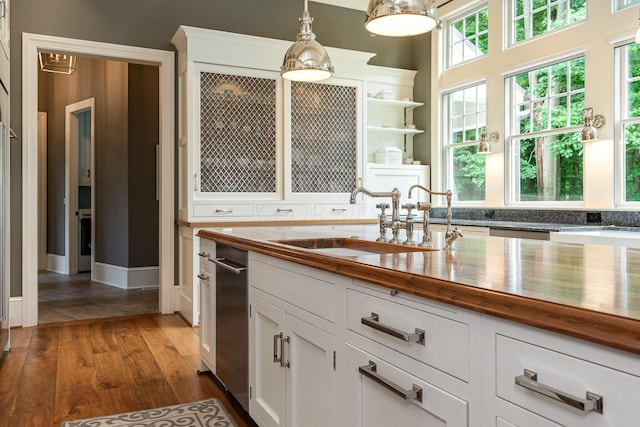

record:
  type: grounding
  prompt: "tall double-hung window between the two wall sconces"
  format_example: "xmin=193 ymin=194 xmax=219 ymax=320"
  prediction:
xmin=507 ymin=56 xmax=585 ymax=202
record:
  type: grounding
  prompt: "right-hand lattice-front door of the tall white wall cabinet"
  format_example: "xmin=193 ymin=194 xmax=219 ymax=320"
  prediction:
xmin=285 ymin=79 xmax=362 ymax=202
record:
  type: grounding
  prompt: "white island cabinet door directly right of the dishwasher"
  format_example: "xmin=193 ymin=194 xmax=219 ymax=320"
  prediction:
xmin=249 ymin=297 xmax=286 ymax=427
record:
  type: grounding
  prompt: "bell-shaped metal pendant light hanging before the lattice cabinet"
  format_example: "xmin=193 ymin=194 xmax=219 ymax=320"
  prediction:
xmin=280 ymin=0 xmax=334 ymax=82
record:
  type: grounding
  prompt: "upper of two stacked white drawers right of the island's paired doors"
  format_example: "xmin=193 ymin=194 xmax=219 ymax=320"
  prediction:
xmin=347 ymin=289 xmax=469 ymax=381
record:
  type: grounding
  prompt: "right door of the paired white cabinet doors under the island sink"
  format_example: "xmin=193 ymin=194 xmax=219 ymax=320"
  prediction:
xmin=285 ymin=315 xmax=339 ymax=427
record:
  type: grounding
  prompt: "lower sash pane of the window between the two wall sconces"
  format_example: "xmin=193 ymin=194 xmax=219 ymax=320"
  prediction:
xmin=511 ymin=132 xmax=584 ymax=202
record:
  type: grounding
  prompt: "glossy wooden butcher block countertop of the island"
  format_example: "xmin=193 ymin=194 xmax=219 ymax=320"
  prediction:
xmin=198 ymin=225 xmax=640 ymax=354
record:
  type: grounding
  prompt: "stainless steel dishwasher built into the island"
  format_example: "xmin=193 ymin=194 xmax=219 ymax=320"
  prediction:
xmin=212 ymin=243 xmax=249 ymax=411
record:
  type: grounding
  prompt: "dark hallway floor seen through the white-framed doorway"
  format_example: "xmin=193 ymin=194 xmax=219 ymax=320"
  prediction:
xmin=38 ymin=271 xmax=160 ymax=324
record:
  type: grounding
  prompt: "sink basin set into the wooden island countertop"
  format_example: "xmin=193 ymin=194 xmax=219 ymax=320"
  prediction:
xmin=273 ymin=237 xmax=438 ymax=256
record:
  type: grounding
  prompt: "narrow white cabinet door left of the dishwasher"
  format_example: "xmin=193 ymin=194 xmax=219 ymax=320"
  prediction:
xmin=198 ymin=270 xmax=216 ymax=372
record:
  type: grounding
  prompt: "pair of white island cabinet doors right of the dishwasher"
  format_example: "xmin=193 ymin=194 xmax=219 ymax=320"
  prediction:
xmin=249 ymin=295 xmax=337 ymax=427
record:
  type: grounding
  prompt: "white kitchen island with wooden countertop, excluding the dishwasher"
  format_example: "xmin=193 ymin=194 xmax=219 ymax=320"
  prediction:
xmin=198 ymin=224 xmax=640 ymax=427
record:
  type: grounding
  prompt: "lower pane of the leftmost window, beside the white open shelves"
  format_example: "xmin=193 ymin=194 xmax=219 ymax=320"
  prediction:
xmin=451 ymin=146 xmax=487 ymax=201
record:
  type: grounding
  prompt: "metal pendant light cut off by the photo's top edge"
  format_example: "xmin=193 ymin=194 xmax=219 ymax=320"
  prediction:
xmin=364 ymin=0 xmax=442 ymax=37
